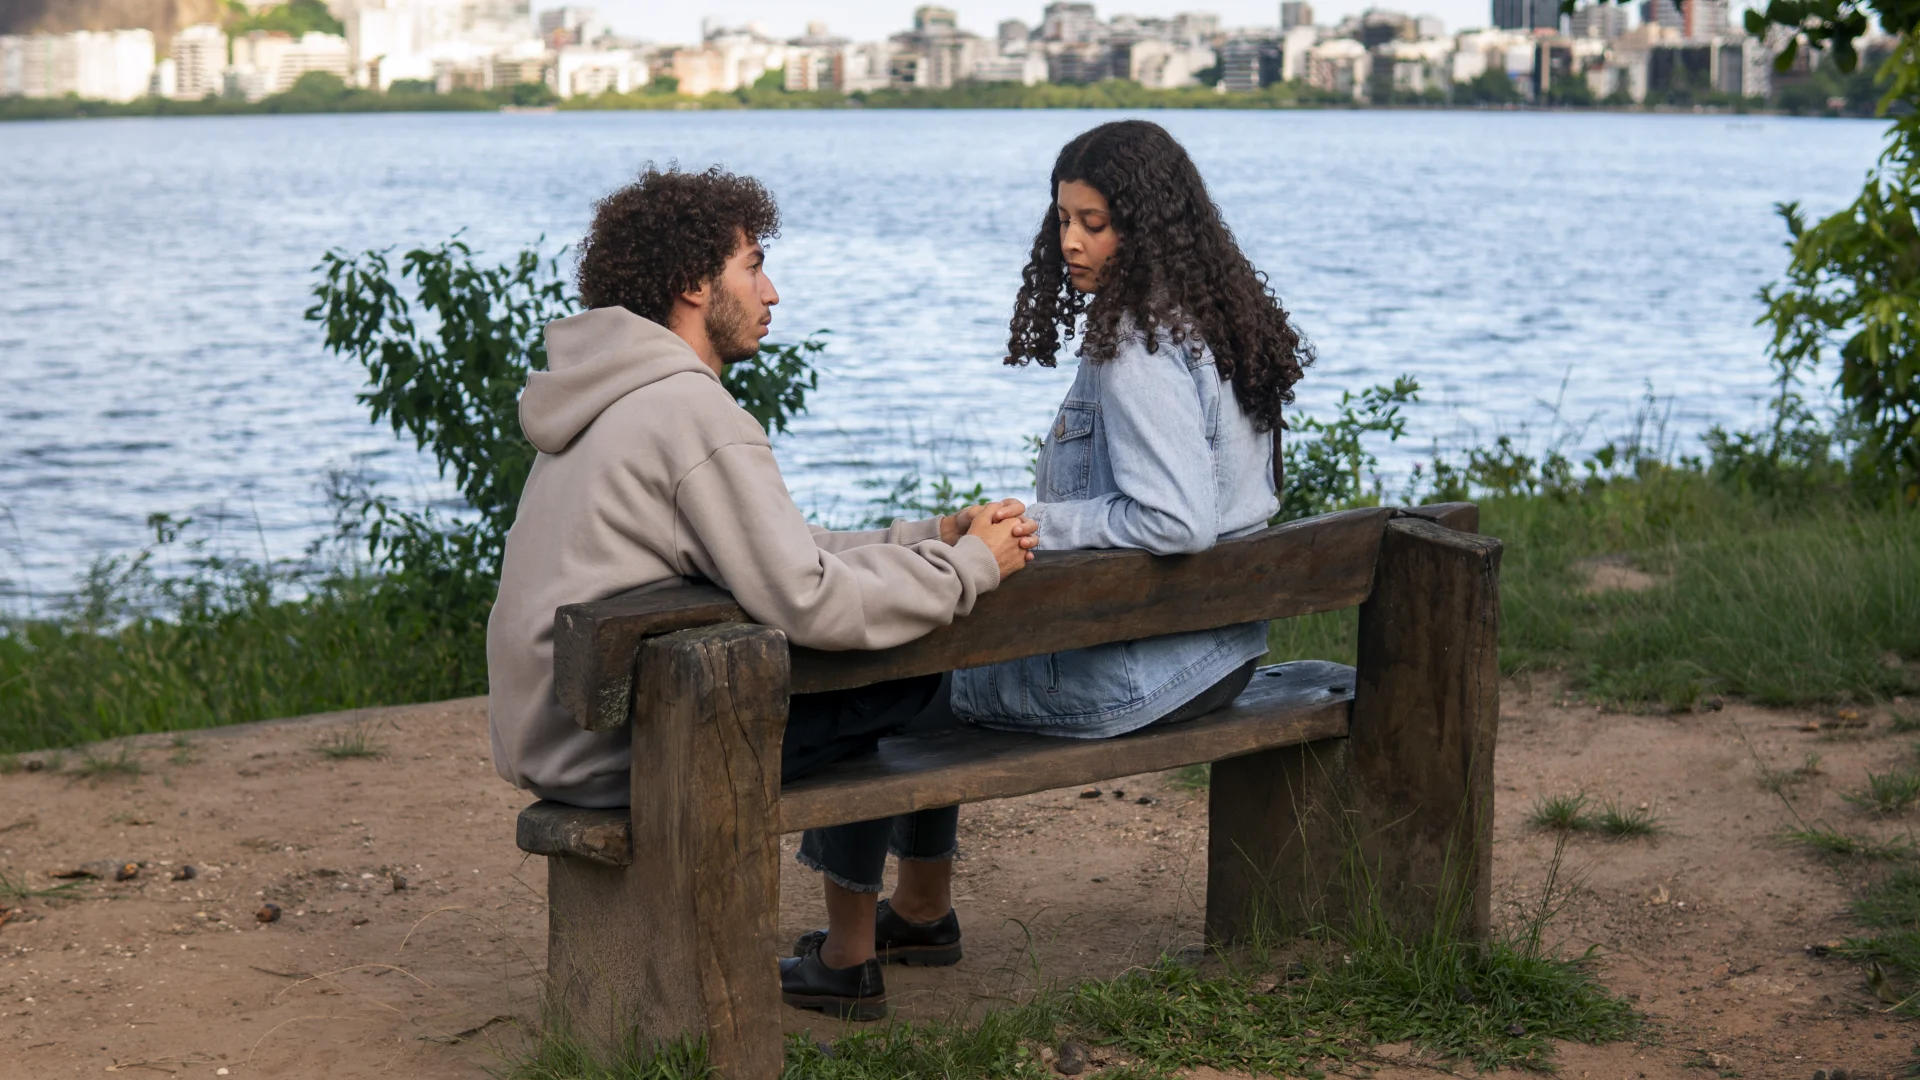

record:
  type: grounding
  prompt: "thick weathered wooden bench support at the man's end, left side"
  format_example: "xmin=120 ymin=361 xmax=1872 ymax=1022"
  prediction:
xmin=547 ymin=623 xmax=789 ymax=1080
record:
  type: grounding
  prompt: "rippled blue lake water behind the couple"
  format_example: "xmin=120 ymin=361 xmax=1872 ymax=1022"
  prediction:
xmin=0 ymin=111 xmax=1884 ymax=603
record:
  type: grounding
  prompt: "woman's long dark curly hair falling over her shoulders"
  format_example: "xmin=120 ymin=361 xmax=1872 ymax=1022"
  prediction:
xmin=1006 ymin=119 xmax=1313 ymax=430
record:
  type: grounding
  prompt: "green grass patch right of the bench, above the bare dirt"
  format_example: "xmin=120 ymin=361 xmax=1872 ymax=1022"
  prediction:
xmin=1267 ymin=469 xmax=1920 ymax=707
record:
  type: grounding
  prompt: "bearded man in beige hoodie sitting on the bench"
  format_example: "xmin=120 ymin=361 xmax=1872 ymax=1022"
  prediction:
xmin=488 ymin=167 xmax=1035 ymax=1019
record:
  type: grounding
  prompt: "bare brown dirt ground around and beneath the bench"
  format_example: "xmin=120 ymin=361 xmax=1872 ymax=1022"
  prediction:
xmin=0 ymin=682 xmax=1920 ymax=1080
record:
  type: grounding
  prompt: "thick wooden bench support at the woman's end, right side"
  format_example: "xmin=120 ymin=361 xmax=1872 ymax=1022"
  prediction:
xmin=1206 ymin=517 xmax=1500 ymax=942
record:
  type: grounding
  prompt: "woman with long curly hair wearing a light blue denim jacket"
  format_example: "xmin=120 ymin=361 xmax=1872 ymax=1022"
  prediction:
xmin=952 ymin=119 xmax=1313 ymax=738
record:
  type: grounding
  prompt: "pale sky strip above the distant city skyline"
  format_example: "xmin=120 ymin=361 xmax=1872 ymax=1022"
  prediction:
xmin=583 ymin=0 xmax=1492 ymax=42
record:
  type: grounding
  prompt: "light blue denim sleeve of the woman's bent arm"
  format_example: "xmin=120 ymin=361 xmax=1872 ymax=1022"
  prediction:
xmin=1027 ymin=344 xmax=1219 ymax=555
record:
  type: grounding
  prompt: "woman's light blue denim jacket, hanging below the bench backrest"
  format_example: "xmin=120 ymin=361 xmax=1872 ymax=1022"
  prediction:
xmin=952 ymin=322 xmax=1279 ymax=738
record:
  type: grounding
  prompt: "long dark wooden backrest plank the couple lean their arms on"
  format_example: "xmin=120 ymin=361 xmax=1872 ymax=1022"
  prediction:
xmin=553 ymin=503 xmax=1478 ymax=730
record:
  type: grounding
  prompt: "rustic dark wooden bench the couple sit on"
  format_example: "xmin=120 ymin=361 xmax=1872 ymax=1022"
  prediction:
xmin=518 ymin=503 xmax=1500 ymax=1080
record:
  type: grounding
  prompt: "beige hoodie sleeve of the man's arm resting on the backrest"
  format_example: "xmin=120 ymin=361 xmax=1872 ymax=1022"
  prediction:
xmin=674 ymin=444 xmax=1000 ymax=650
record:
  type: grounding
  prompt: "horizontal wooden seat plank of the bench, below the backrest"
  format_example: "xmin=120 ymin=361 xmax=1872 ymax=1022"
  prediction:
xmin=518 ymin=661 xmax=1354 ymax=867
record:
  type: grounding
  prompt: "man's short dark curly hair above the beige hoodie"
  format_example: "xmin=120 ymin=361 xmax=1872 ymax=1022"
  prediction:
xmin=576 ymin=163 xmax=780 ymax=327
